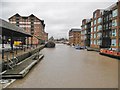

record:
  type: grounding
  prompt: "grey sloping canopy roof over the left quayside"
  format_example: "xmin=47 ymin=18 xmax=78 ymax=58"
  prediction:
xmin=0 ymin=19 xmax=32 ymax=37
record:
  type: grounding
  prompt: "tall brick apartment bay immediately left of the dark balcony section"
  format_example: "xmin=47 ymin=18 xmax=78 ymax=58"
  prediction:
xmin=90 ymin=9 xmax=104 ymax=49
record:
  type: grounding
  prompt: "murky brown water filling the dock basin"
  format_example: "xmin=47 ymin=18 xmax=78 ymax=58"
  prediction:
xmin=9 ymin=44 xmax=118 ymax=88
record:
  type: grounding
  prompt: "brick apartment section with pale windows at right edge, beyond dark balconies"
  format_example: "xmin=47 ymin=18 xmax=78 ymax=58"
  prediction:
xmin=109 ymin=1 xmax=120 ymax=49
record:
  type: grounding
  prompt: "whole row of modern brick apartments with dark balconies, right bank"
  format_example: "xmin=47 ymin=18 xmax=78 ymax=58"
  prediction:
xmin=81 ymin=1 xmax=120 ymax=50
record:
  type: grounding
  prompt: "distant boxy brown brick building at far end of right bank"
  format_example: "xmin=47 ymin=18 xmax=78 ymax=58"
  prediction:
xmin=69 ymin=28 xmax=81 ymax=45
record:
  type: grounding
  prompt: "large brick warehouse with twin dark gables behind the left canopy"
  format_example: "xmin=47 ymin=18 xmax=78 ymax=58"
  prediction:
xmin=9 ymin=14 xmax=48 ymax=44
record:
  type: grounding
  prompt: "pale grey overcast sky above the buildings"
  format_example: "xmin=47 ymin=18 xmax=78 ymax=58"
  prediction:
xmin=0 ymin=0 xmax=118 ymax=39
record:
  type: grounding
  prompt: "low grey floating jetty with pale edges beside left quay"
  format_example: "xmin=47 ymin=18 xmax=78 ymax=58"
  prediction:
xmin=0 ymin=47 xmax=44 ymax=88
